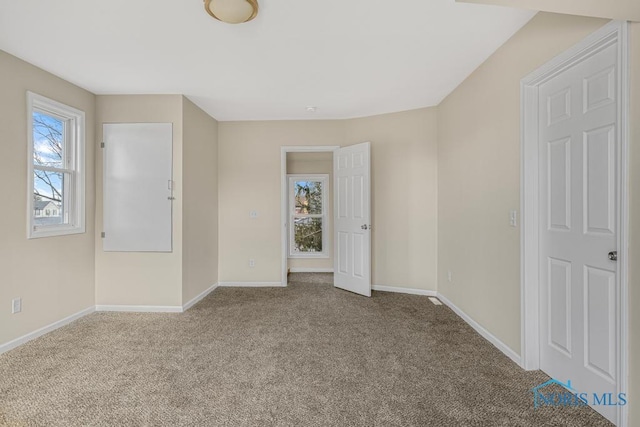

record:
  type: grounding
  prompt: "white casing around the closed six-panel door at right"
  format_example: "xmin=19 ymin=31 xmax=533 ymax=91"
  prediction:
xmin=520 ymin=21 xmax=629 ymax=427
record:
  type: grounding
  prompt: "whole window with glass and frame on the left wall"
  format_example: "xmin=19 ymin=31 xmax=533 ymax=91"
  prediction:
xmin=27 ymin=92 xmax=85 ymax=238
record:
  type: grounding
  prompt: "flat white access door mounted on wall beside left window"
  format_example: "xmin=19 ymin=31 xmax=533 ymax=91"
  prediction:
xmin=102 ymin=123 xmax=173 ymax=252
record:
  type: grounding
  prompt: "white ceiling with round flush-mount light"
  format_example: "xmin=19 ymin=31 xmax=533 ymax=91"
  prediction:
xmin=0 ymin=0 xmax=534 ymax=121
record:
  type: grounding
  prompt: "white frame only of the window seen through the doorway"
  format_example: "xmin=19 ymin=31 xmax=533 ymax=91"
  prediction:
xmin=287 ymin=174 xmax=330 ymax=258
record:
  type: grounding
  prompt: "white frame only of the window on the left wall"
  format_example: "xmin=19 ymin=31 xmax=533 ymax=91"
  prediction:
xmin=27 ymin=92 xmax=85 ymax=239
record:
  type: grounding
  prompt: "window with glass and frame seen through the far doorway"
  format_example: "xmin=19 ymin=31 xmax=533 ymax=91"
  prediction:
xmin=289 ymin=175 xmax=329 ymax=258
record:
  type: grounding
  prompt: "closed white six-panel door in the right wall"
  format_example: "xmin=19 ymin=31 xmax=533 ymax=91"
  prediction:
xmin=538 ymin=44 xmax=620 ymax=420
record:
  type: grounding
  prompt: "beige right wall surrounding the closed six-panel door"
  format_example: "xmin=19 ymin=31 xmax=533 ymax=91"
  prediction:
xmin=438 ymin=13 xmax=640 ymax=425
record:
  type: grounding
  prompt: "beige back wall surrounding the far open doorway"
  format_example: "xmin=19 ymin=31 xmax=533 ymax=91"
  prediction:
xmin=218 ymin=108 xmax=437 ymax=290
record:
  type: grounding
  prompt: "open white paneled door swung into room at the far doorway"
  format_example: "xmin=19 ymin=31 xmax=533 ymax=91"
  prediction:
xmin=333 ymin=142 xmax=371 ymax=297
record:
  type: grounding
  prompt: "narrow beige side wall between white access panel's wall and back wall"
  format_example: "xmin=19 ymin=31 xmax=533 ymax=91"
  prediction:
xmin=182 ymin=98 xmax=218 ymax=304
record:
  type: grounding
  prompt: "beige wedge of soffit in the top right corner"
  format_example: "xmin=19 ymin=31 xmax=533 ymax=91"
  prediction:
xmin=456 ymin=0 xmax=640 ymax=21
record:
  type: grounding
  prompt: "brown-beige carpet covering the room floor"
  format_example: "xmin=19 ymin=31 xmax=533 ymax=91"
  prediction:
xmin=0 ymin=274 xmax=610 ymax=427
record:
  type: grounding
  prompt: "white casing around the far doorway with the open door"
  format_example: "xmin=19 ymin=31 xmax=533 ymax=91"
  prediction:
xmin=280 ymin=145 xmax=340 ymax=286
